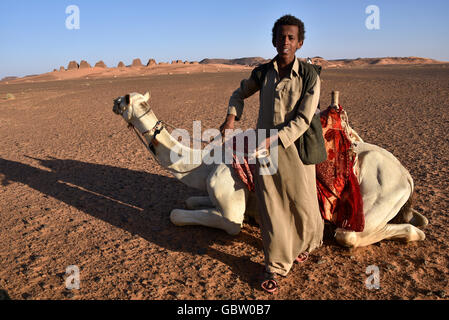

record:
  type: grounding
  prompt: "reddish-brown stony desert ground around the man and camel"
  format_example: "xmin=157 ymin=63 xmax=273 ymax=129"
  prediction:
xmin=0 ymin=64 xmax=449 ymax=300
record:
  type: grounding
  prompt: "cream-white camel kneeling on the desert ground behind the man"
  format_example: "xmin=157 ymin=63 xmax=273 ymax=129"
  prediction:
xmin=113 ymin=92 xmax=428 ymax=247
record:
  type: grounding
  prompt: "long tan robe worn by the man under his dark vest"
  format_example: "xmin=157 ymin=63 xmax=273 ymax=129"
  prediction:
xmin=228 ymin=59 xmax=324 ymax=276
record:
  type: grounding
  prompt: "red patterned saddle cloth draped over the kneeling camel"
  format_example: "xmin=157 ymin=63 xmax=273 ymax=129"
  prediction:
xmin=232 ymin=106 xmax=365 ymax=232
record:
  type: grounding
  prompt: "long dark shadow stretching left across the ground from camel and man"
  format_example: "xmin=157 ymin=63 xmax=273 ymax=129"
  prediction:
xmin=0 ymin=157 xmax=262 ymax=285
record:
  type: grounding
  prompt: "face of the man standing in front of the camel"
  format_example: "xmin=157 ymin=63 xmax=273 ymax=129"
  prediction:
xmin=274 ymin=26 xmax=303 ymax=62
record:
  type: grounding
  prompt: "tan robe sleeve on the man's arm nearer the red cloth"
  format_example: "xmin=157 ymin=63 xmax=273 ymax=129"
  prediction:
xmin=278 ymin=76 xmax=321 ymax=148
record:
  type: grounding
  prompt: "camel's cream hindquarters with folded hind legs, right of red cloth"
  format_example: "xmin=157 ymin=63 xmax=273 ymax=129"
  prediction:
xmin=335 ymin=143 xmax=427 ymax=247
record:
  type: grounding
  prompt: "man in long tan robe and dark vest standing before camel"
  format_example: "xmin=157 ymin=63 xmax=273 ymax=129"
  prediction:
xmin=220 ymin=15 xmax=324 ymax=292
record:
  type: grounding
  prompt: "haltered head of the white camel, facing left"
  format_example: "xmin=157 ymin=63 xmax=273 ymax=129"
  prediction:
xmin=112 ymin=92 xmax=158 ymax=132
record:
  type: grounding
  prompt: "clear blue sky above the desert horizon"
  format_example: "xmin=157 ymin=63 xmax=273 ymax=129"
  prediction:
xmin=0 ymin=0 xmax=449 ymax=79
